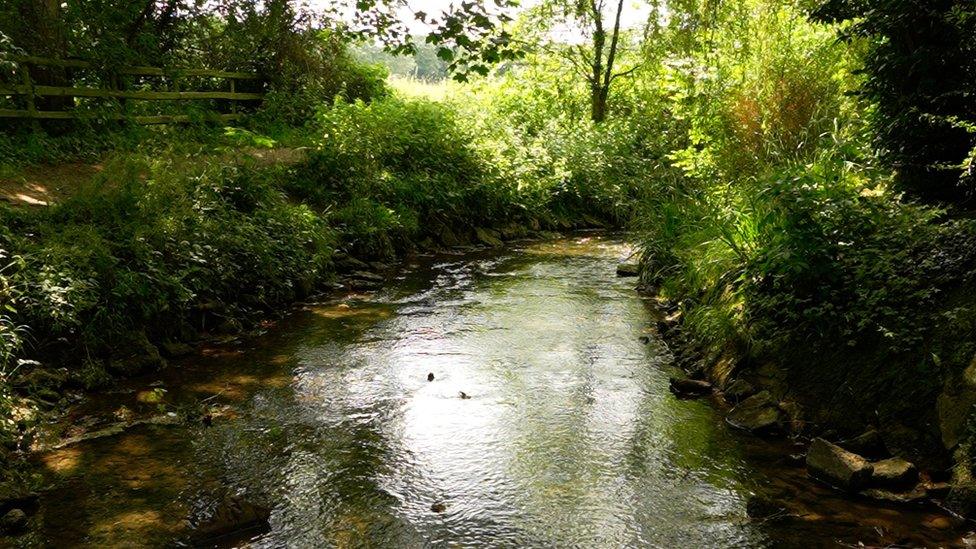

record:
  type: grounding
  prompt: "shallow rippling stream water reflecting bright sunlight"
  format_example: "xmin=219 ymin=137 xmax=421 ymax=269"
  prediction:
xmin=20 ymin=235 xmax=960 ymax=547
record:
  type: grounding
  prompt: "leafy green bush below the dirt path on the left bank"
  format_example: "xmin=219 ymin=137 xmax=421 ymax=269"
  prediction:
xmin=3 ymin=157 xmax=333 ymax=360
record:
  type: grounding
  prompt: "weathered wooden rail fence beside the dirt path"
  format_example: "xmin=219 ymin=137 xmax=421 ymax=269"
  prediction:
xmin=0 ymin=56 xmax=264 ymax=124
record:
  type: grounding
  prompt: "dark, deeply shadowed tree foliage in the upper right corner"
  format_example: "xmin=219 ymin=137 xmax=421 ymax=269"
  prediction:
xmin=812 ymin=0 xmax=976 ymax=202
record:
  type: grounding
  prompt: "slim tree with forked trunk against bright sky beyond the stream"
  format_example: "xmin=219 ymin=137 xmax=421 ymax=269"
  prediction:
xmin=528 ymin=0 xmax=639 ymax=124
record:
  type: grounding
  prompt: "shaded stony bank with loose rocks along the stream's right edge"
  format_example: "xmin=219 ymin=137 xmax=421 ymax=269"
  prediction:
xmin=642 ymin=278 xmax=976 ymax=527
